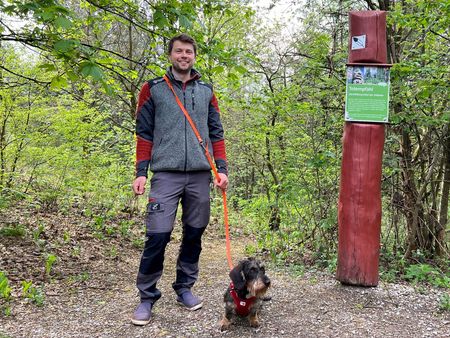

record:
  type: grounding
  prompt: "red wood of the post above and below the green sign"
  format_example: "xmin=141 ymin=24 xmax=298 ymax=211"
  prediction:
xmin=336 ymin=11 xmax=387 ymax=286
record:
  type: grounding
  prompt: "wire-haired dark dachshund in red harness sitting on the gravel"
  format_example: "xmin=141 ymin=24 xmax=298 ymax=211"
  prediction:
xmin=220 ymin=258 xmax=270 ymax=331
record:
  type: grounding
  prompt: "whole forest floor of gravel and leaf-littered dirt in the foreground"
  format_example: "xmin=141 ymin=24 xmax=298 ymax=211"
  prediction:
xmin=0 ymin=207 xmax=450 ymax=337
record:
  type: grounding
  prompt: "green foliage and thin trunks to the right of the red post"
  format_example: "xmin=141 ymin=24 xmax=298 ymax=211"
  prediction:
xmin=383 ymin=1 xmax=450 ymax=258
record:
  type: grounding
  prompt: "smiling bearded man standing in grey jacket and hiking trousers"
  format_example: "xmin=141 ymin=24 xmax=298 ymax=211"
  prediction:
xmin=132 ymin=34 xmax=228 ymax=325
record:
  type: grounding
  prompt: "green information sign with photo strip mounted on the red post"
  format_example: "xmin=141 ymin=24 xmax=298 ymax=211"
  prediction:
xmin=345 ymin=66 xmax=389 ymax=123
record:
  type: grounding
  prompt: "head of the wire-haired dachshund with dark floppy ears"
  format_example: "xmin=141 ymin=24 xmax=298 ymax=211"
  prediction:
xmin=230 ymin=258 xmax=270 ymax=297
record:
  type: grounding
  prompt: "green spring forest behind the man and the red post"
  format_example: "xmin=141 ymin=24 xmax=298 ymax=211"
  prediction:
xmin=0 ymin=0 xmax=450 ymax=309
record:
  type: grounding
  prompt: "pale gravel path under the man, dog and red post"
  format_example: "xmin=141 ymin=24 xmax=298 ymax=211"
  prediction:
xmin=0 ymin=232 xmax=450 ymax=337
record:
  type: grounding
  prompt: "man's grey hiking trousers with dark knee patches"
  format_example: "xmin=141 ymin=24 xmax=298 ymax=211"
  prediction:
xmin=136 ymin=171 xmax=211 ymax=303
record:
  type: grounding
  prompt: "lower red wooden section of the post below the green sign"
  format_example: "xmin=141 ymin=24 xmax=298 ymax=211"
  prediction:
xmin=337 ymin=122 xmax=384 ymax=286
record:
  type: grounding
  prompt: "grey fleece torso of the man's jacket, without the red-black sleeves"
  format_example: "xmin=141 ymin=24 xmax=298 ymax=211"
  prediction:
xmin=150 ymin=74 xmax=213 ymax=172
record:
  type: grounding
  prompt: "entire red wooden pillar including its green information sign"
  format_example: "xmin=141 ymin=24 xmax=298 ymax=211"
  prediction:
xmin=336 ymin=11 xmax=390 ymax=286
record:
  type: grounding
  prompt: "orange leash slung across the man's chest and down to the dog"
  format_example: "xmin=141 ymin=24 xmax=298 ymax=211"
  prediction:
xmin=164 ymin=75 xmax=234 ymax=270
